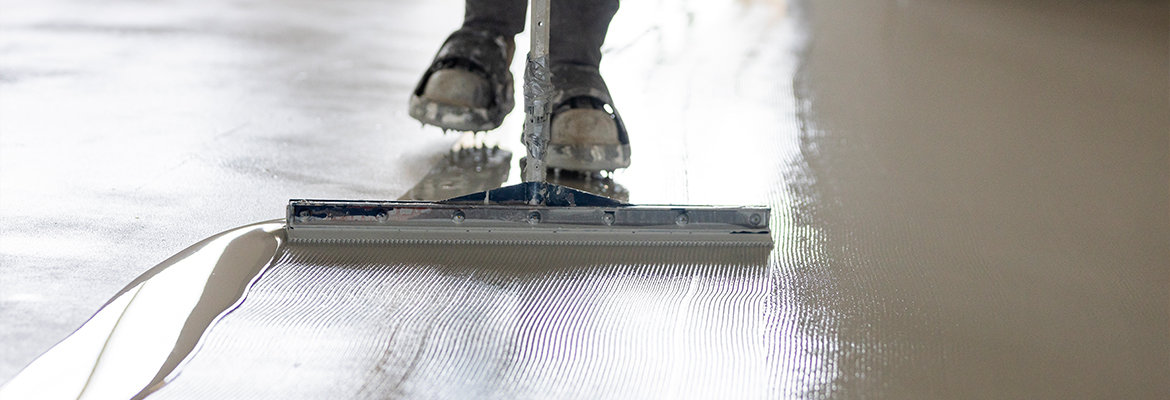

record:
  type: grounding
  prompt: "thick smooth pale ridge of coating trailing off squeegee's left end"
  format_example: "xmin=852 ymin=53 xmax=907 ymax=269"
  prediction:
xmin=0 ymin=222 xmax=284 ymax=399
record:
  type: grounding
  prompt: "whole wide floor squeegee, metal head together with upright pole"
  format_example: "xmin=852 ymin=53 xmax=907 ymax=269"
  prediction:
xmin=287 ymin=0 xmax=772 ymax=246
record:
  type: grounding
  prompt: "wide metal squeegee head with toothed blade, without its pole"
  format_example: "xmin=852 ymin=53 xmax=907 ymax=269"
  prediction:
xmin=287 ymin=184 xmax=772 ymax=246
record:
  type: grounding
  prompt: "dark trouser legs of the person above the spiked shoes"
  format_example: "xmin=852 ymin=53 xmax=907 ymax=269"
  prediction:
xmin=463 ymin=0 xmax=618 ymax=68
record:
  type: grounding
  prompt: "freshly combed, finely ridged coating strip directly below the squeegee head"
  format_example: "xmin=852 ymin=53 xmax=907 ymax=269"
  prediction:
xmin=150 ymin=243 xmax=782 ymax=399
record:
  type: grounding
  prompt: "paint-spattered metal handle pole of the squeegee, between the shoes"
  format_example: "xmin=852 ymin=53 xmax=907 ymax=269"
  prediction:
xmin=523 ymin=0 xmax=553 ymax=187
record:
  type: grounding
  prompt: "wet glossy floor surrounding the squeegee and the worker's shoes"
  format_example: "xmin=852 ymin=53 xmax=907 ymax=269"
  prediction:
xmin=0 ymin=0 xmax=1170 ymax=399
